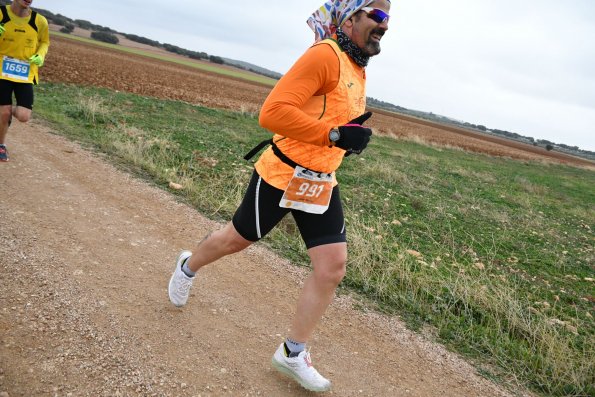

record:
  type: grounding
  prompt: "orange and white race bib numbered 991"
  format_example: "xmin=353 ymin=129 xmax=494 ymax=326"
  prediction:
xmin=279 ymin=166 xmax=333 ymax=214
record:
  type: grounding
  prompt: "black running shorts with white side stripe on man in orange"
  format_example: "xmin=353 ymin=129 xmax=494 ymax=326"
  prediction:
xmin=232 ymin=171 xmax=347 ymax=248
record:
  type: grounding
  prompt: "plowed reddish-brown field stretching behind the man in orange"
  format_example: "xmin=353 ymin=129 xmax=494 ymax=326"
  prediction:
xmin=41 ymin=37 xmax=595 ymax=167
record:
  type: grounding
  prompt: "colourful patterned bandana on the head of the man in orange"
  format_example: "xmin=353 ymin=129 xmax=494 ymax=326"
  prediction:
xmin=307 ymin=0 xmax=390 ymax=41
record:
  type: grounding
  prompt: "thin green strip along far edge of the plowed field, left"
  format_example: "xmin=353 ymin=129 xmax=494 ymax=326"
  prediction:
xmin=51 ymin=31 xmax=277 ymax=86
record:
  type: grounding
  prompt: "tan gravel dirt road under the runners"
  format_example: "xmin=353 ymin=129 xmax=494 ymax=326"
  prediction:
xmin=0 ymin=122 xmax=528 ymax=397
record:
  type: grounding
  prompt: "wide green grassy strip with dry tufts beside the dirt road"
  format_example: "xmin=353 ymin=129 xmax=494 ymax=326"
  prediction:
xmin=35 ymin=84 xmax=595 ymax=396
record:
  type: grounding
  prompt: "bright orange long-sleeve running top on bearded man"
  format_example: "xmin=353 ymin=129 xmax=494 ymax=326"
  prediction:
xmin=255 ymin=39 xmax=365 ymax=189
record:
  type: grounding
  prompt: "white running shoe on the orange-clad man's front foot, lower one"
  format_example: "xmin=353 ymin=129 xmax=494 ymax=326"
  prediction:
xmin=271 ymin=343 xmax=331 ymax=391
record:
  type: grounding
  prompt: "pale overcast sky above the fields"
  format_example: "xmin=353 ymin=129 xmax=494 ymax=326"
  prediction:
xmin=42 ymin=0 xmax=595 ymax=151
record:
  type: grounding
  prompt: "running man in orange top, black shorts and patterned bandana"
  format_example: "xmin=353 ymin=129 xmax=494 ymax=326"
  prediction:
xmin=169 ymin=0 xmax=390 ymax=391
